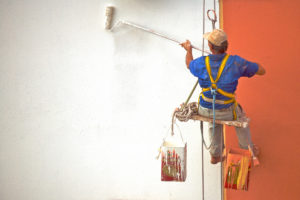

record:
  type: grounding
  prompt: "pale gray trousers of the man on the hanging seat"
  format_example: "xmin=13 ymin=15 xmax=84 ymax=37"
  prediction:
xmin=198 ymin=105 xmax=253 ymax=157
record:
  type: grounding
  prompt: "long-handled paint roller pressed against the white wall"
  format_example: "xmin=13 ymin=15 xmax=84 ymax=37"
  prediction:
xmin=105 ymin=6 xmax=210 ymax=54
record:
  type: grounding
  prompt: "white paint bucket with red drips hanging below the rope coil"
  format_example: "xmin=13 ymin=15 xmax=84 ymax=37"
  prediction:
xmin=161 ymin=131 xmax=187 ymax=182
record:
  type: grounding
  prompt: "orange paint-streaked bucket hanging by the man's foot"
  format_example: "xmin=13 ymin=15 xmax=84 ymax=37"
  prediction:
xmin=224 ymin=148 xmax=251 ymax=191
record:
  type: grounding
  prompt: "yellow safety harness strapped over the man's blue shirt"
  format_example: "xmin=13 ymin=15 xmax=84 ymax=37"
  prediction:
xmin=198 ymin=54 xmax=237 ymax=120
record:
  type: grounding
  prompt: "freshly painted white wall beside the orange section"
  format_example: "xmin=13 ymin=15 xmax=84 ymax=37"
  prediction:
xmin=0 ymin=0 xmax=220 ymax=200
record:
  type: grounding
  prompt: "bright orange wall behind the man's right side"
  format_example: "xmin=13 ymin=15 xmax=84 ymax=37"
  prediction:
xmin=223 ymin=0 xmax=300 ymax=200
